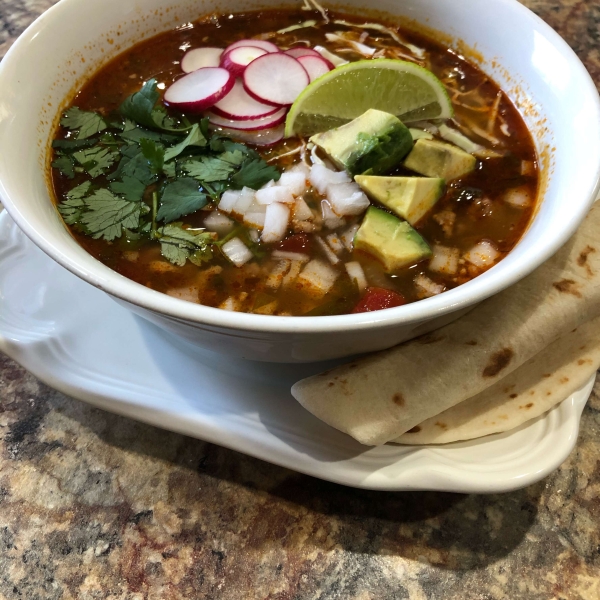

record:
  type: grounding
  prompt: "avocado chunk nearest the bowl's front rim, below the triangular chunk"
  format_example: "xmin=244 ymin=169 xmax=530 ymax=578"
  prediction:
xmin=354 ymin=206 xmax=432 ymax=273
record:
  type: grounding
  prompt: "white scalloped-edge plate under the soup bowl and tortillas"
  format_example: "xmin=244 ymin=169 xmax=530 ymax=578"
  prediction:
xmin=0 ymin=212 xmax=594 ymax=493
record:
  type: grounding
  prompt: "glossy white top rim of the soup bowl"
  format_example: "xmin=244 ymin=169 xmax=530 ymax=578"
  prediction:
xmin=0 ymin=0 xmax=600 ymax=334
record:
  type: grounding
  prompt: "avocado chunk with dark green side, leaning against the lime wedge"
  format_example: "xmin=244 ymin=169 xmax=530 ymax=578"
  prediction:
xmin=310 ymin=108 xmax=413 ymax=175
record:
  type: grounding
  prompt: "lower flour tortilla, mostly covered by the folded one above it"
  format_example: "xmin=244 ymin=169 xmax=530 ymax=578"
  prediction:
xmin=394 ymin=318 xmax=600 ymax=444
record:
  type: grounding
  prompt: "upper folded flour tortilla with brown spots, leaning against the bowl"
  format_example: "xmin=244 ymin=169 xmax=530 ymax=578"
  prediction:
xmin=292 ymin=204 xmax=600 ymax=446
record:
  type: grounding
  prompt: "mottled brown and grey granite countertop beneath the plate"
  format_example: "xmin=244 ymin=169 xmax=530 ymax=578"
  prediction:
xmin=0 ymin=0 xmax=600 ymax=600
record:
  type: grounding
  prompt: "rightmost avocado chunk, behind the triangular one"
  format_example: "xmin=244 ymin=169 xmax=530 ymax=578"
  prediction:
xmin=404 ymin=139 xmax=477 ymax=181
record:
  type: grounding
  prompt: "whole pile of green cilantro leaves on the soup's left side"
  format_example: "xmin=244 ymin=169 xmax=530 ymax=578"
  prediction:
xmin=52 ymin=79 xmax=280 ymax=265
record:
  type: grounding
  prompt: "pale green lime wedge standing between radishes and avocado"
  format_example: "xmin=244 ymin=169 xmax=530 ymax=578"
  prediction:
xmin=285 ymin=58 xmax=453 ymax=137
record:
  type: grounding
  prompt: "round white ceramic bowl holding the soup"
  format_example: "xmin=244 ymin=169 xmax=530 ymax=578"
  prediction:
xmin=0 ymin=0 xmax=600 ymax=362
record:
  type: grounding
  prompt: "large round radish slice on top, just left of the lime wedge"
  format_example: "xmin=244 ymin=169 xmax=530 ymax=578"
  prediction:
xmin=244 ymin=52 xmax=310 ymax=106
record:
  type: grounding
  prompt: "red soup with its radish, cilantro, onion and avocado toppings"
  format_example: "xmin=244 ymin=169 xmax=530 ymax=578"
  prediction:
xmin=52 ymin=10 xmax=538 ymax=316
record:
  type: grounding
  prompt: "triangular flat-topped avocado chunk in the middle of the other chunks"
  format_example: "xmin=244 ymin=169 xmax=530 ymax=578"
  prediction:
xmin=354 ymin=175 xmax=445 ymax=225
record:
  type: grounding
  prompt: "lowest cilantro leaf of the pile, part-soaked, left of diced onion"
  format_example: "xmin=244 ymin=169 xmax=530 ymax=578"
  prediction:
xmin=156 ymin=222 xmax=213 ymax=267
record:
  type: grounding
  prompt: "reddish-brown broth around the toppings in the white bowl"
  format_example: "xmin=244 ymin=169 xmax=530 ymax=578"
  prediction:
xmin=52 ymin=10 xmax=538 ymax=315
